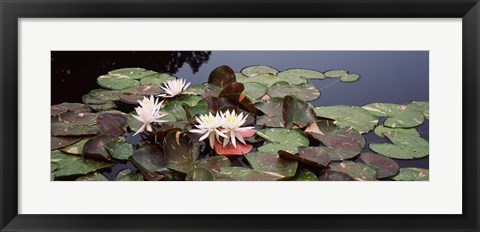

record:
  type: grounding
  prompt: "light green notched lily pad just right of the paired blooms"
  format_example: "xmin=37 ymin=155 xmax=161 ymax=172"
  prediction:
xmin=257 ymin=128 xmax=310 ymax=154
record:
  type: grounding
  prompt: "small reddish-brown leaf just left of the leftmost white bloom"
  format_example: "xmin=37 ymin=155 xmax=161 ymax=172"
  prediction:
xmin=97 ymin=114 xmax=127 ymax=136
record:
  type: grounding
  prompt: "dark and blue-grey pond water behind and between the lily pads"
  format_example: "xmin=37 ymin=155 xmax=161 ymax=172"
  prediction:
xmin=51 ymin=51 xmax=429 ymax=179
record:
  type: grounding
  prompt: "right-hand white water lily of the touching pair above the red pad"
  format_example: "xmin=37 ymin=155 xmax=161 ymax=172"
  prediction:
xmin=222 ymin=110 xmax=254 ymax=148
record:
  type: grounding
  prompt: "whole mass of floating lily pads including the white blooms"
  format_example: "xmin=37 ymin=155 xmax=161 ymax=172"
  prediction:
xmin=51 ymin=65 xmax=429 ymax=181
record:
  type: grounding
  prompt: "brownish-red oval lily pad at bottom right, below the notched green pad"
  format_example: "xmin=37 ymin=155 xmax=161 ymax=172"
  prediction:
xmin=360 ymin=152 xmax=400 ymax=179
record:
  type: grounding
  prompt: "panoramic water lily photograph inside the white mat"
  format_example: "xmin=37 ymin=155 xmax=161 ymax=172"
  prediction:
xmin=50 ymin=51 xmax=429 ymax=181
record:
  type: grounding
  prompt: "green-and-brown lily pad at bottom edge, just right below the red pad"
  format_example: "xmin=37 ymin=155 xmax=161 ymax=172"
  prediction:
xmin=245 ymin=152 xmax=298 ymax=177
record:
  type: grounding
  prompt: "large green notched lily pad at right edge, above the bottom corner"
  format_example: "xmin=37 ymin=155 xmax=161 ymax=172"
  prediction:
xmin=369 ymin=131 xmax=429 ymax=159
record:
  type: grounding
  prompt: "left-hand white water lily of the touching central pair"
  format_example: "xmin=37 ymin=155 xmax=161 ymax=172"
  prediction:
xmin=190 ymin=113 xmax=227 ymax=148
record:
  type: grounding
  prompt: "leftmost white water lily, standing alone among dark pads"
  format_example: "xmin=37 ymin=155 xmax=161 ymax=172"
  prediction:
xmin=133 ymin=96 xmax=167 ymax=136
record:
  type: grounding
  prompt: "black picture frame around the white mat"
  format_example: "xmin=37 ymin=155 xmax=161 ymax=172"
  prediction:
xmin=0 ymin=0 xmax=480 ymax=231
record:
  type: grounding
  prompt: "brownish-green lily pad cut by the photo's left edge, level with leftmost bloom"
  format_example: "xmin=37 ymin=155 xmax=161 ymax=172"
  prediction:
xmin=51 ymin=112 xmax=100 ymax=136
